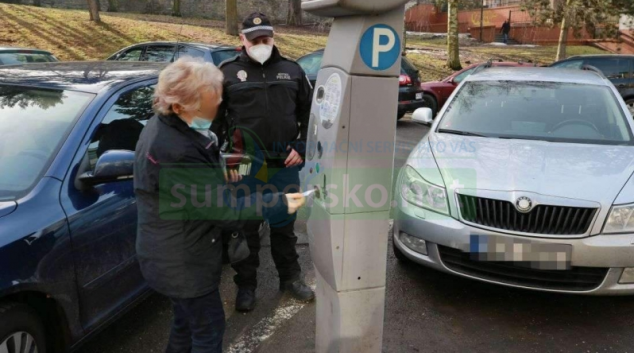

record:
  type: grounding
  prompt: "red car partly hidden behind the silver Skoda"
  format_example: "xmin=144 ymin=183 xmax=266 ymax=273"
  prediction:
xmin=421 ymin=61 xmax=535 ymax=116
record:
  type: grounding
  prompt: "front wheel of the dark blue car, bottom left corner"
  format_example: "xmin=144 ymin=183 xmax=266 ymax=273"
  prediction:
xmin=0 ymin=303 xmax=46 ymax=353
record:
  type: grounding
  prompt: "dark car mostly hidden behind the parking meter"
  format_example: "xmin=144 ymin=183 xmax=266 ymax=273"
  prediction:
xmin=297 ymin=49 xmax=425 ymax=119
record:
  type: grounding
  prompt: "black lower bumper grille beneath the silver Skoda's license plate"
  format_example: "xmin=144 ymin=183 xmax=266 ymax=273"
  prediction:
xmin=438 ymin=245 xmax=608 ymax=291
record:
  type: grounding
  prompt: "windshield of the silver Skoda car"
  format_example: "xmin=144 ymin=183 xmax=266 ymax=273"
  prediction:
xmin=438 ymin=81 xmax=632 ymax=145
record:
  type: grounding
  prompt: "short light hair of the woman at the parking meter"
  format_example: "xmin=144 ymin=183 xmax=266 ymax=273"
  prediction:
xmin=154 ymin=56 xmax=224 ymax=115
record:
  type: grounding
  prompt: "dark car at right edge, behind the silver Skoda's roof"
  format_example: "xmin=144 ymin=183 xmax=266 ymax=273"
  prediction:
xmin=552 ymin=55 xmax=634 ymax=114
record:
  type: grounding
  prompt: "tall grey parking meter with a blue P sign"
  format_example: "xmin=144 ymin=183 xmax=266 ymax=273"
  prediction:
xmin=301 ymin=0 xmax=407 ymax=352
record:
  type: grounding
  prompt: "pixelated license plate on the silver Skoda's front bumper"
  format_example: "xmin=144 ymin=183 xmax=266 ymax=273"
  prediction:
xmin=469 ymin=235 xmax=572 ymax=270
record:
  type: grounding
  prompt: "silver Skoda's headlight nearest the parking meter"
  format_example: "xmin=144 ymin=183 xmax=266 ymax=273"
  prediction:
xmin=401 ymin=166 xmax=449 ymax=215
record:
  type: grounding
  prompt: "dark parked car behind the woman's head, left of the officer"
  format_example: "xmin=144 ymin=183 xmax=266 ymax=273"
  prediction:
xmin=108 ymin=42 xmax=242 ymax=65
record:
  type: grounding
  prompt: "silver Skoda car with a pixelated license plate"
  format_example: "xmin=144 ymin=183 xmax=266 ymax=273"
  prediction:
xmin=393 ymin=67 xmax=634 ymax=295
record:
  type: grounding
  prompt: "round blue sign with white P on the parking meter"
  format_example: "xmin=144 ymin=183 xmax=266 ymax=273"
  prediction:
xmin=360 ymin=24 xmax=401 ymax=71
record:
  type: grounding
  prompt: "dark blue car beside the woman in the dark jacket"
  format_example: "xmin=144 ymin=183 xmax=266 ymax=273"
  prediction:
xmin=0 ymin=61 xmax=165 ymax=353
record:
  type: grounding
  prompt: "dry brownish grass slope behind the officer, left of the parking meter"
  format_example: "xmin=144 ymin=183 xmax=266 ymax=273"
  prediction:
xmin=0 ymin=4 xmax=327 ymax=60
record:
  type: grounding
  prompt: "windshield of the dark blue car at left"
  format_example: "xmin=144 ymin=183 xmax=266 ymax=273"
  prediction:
xmin=0 ymin=85 xmax=93 ymax=201
